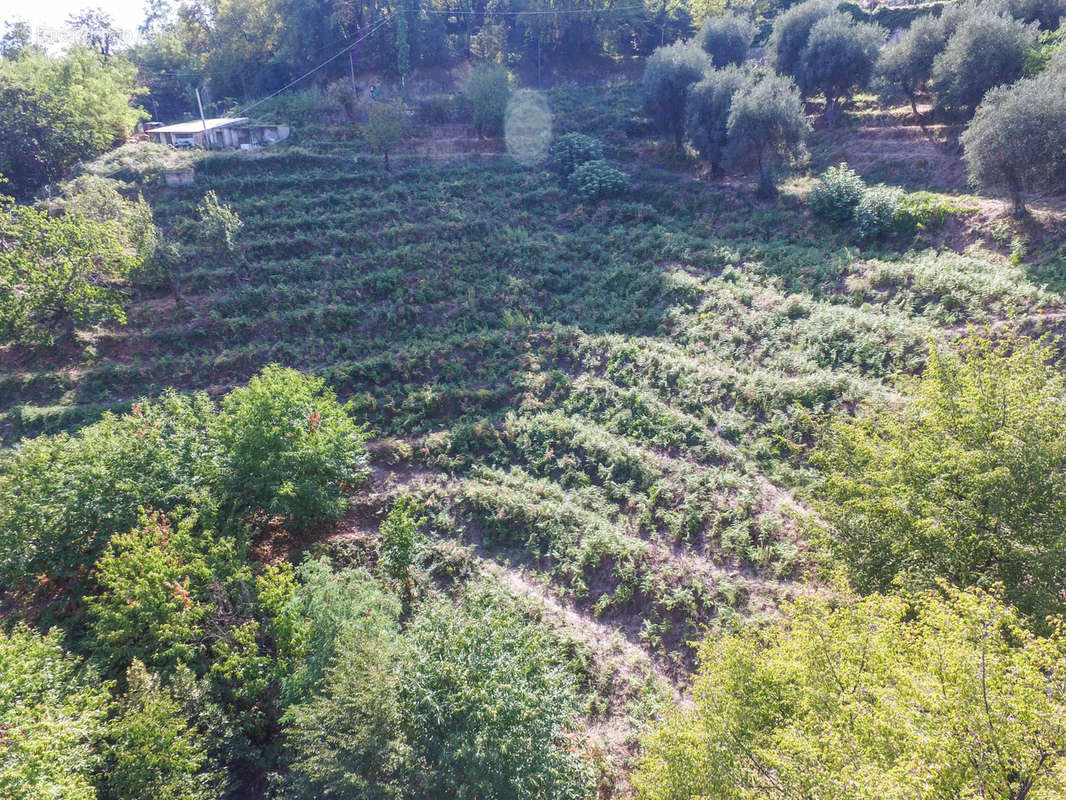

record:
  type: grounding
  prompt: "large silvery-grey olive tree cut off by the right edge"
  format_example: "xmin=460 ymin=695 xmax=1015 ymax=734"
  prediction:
xmin=962 ymin=70 xmax=1066 ymax=215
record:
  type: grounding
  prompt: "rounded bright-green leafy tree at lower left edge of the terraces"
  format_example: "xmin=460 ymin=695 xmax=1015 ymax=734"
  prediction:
xmin=217 ymin=365 xmax=367 ymax=530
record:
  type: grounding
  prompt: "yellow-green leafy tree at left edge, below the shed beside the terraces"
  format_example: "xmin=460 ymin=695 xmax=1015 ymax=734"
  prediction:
xmin=0 ymin=195 xmax=142 ymax=345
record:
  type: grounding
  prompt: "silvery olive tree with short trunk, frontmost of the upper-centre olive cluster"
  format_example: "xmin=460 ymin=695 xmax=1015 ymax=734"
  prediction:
xmin=726 ymin=74 xmax=810 ymax=197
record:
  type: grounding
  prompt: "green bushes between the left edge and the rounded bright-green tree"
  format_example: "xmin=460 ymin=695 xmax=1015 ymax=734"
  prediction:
xmin=0 ymin=394 xmax=216 ymax=587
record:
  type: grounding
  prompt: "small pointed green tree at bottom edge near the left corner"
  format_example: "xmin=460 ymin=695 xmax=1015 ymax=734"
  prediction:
xmin=106 ymin=660 xmax=220 ymax=800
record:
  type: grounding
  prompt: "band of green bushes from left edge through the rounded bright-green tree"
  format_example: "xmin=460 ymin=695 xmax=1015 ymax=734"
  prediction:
xmin=0 ymin=367 xmax=366 ymax=588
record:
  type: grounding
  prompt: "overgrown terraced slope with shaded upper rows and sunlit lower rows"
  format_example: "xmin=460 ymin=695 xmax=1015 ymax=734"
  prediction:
xmin=0 ymin=80 xmax=1063 ymax=782
